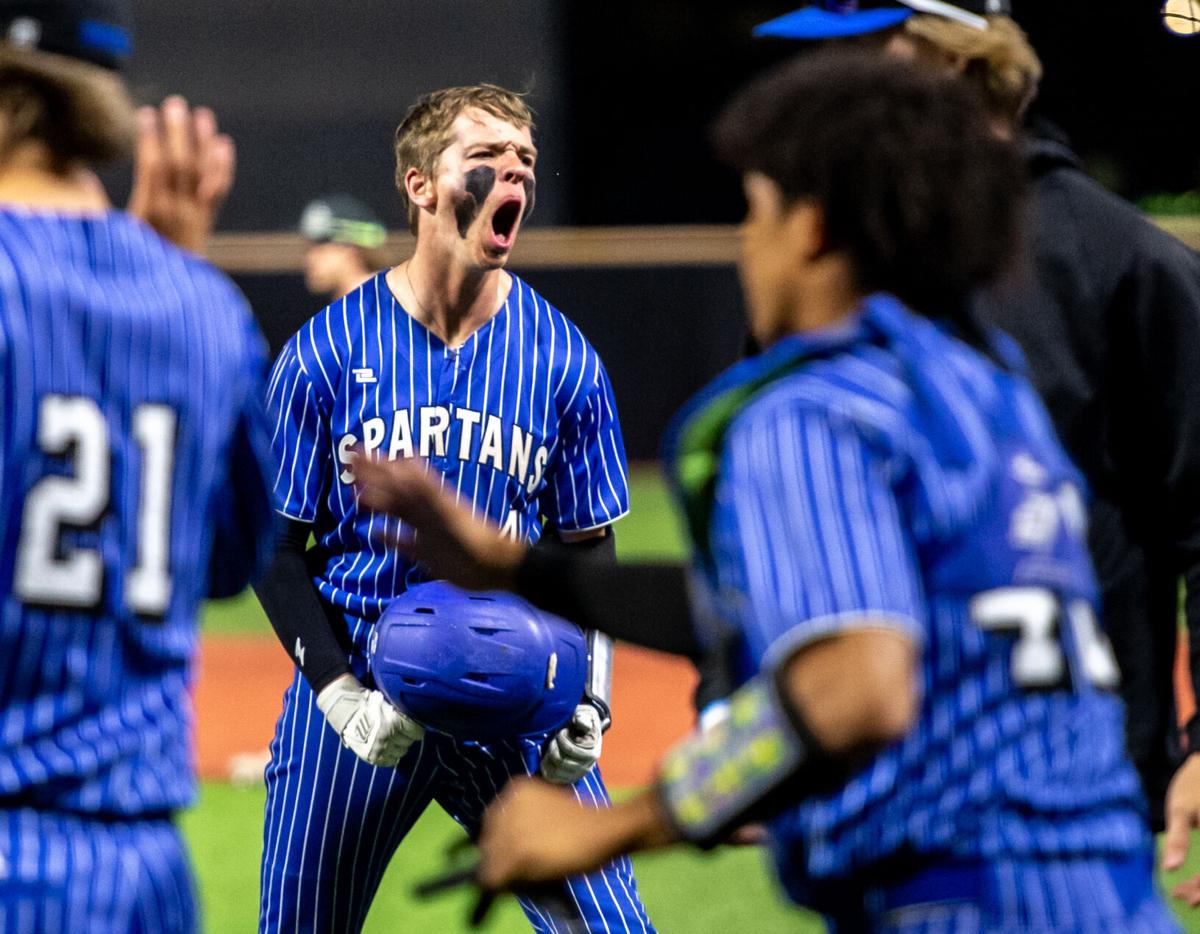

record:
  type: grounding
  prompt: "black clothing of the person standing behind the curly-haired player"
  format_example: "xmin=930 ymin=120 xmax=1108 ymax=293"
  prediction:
xmin=980 ymin=118 xmax=1200 ymax=845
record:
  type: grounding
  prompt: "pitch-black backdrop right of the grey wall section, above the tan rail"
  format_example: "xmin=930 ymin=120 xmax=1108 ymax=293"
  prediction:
xmin=564 ymin=0 xmax=1200 ymax=223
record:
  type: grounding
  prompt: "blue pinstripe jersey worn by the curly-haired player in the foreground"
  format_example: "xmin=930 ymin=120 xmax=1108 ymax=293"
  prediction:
xmin=680 ymin=297 xmax=1148 ymax=904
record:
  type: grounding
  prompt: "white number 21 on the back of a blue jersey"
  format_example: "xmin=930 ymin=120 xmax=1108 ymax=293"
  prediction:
xmin=13 ymin=395 xmax=175 ymax=616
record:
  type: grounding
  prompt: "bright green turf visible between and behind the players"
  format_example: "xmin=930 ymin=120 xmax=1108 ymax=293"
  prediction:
xmin=182 ymin=469 xmax=1200 ymax=934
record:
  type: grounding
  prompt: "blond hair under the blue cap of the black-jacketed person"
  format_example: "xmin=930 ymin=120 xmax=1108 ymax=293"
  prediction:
xmin=904 ymin=14 xmax=1042 ymax=124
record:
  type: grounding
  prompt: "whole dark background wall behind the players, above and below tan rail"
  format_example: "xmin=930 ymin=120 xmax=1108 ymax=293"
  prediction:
xmin=109 ymin=0 xmax=1200 ymax=457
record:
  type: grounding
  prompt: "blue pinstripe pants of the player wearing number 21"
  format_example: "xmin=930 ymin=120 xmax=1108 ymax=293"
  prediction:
xmin=0 ymin=808 xmax=197 ymax=934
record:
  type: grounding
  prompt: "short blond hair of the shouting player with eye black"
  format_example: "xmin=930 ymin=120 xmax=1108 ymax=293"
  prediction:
xmin=396 ymin=84 xmax=533 ymax=234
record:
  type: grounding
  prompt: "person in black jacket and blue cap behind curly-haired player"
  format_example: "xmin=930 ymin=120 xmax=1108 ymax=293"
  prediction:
xmin=756 ymin=0 xmax=1200 ymax=905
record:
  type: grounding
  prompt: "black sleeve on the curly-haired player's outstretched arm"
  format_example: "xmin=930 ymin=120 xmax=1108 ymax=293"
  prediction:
xmin=516 ymin=539 xmax=700 ymax=657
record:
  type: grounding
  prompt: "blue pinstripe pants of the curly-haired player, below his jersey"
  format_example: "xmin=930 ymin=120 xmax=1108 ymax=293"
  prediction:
xmin=829 ymin=852 xmax=1180 ymax=934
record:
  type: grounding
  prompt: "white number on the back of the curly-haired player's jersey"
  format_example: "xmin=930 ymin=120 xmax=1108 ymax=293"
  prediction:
xmin=971 ymin=587 xmax=1120 ymax=690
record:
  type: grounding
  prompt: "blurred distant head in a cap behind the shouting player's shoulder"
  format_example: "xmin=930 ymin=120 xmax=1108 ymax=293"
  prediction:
xmin=300 ymin=194 xmax=388 ymax=301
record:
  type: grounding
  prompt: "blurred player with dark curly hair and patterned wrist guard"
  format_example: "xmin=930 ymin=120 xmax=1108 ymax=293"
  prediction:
xmin=356 ymin=53 xmax=1176 ymax=932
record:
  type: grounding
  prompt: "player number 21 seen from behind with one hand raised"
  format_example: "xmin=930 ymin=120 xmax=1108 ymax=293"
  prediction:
xmin=0 ymin=0 xmax=272 ymax=921
